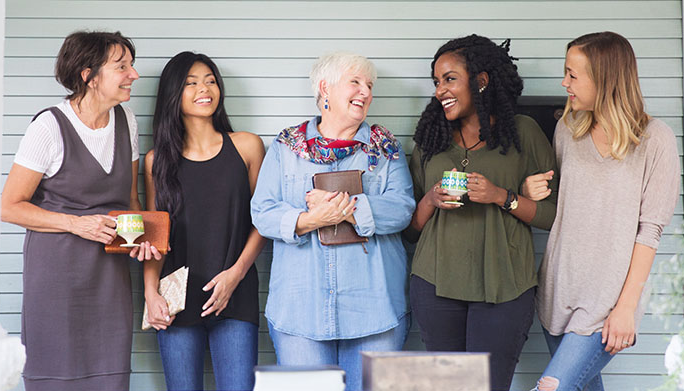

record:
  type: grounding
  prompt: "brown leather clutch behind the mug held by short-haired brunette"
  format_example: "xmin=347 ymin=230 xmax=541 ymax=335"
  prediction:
xmin=105 ymin=210 xmax=171 ymax=254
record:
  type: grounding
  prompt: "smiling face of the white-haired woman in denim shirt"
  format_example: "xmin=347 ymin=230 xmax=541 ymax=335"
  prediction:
xmin=322 ymin=70 xmax=373 ymax=124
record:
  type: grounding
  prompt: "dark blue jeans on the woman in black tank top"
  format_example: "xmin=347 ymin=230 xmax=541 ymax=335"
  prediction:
xmin=157 ymin=318 xmax=258 ymax=391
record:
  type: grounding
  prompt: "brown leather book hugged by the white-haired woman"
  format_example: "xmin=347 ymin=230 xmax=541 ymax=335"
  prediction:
xmin=312 ymin=170 xmax=368 ymax=246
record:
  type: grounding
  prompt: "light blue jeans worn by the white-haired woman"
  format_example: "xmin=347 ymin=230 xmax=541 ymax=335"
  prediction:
xmin=268 ymin=315 xmax=410 ymax=391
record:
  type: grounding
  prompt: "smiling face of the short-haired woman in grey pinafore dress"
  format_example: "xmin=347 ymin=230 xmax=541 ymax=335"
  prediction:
xmin=88 ymin=46 xmax=140 ymax=106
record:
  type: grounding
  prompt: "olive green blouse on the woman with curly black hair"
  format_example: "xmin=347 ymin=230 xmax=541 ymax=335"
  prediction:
xmin=405 ymin=115 xmax=559 ymax=303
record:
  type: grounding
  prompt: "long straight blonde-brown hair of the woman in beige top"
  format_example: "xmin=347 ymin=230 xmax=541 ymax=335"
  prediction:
xmin=563 ymin=31 xmax=650 ymax=160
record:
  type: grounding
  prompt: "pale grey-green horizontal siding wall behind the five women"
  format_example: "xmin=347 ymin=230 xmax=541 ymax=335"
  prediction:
xmin=0 ymin=0 xmax=684 ymax=390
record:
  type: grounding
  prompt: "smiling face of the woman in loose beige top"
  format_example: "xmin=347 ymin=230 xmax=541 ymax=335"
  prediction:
xmin=561 ymin=46 xmax=596 ymax=111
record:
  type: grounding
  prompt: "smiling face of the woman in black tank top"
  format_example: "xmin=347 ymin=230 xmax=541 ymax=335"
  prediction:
xmin=181 ymin=62 xmax=221 ymax=117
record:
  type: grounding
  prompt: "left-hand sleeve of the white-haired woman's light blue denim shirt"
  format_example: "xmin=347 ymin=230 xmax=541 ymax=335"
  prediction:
xmin=250 ymin=142 xmax=308 ymax=245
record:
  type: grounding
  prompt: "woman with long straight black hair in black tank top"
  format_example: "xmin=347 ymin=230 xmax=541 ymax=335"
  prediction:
xmin=144 ymin=52 xmax=265 ymax=390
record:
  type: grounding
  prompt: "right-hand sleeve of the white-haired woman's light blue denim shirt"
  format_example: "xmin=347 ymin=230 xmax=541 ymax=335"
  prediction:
xmin=354 ymin=147 xmax=416 ymax=236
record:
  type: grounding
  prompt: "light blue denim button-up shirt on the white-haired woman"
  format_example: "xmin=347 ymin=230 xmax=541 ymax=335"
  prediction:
xmin=251 ymin=117 xmax=415 ymax=340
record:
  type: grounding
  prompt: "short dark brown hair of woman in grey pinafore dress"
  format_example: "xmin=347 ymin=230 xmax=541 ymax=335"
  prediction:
xmin=55 ymin=31 xmax=135 ymax=100
